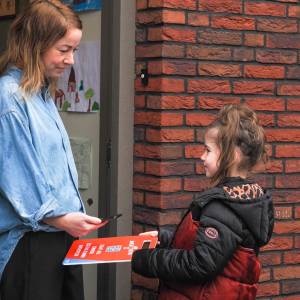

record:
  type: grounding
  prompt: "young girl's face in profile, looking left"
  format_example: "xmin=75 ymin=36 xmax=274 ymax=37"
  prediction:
xmin=201 ymin=128 xmax=220 ymax=178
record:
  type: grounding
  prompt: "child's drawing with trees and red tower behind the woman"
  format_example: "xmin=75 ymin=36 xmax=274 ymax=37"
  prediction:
xmin=54 ymin=42 xmax=100 ymax=112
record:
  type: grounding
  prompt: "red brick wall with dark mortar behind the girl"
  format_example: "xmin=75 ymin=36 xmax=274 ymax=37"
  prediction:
xmin=132 ymin=0 xmax=300 ymax=300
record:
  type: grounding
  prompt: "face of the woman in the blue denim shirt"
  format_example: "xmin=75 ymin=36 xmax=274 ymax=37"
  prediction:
xmin=42 ymin=28 xmax=82 ymax=78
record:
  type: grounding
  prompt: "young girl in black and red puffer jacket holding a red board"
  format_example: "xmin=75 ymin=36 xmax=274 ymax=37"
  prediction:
xmin=132 ymin=105 xmax=274 ymax=300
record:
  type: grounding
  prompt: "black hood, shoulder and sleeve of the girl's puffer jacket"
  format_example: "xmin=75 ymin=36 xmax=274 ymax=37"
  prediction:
xmin=132 ymin=178 xmax=274 ymax=284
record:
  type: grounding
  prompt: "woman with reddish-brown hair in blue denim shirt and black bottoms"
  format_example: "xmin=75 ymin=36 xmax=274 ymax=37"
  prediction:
xmin=0 ymin=0 xmax=105 ymax=300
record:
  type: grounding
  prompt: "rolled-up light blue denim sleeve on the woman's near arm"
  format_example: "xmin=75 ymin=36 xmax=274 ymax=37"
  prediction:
xmin=0 ymin=110 xmax=64 ymax=231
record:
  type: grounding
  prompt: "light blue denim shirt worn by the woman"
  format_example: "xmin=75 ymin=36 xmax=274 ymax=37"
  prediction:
xmin=0 ymin=67 xmax=85 ymax=278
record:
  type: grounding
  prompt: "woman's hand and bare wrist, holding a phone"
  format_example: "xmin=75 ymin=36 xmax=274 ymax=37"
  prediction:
xmin=43 ymin=212 xmax=108 ymax=237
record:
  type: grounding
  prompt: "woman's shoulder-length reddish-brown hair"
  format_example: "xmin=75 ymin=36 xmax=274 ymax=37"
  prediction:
xmin=0 ymin=0 xmax=82 ymax=94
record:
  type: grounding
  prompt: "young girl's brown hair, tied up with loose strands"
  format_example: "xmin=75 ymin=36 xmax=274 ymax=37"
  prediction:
xmin=207 ymin=104 xmax=268 ymax=184
